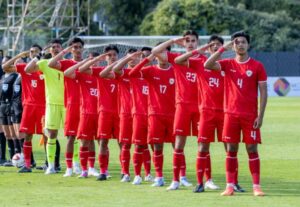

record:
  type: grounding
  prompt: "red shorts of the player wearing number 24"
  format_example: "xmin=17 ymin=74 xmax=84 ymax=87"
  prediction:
xmin=198 ymin=110 xmax=224 ymax=143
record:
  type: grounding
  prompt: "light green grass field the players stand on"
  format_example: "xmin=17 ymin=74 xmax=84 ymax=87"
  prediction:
xmin=0 ymin=98 xmax=300 ymax=207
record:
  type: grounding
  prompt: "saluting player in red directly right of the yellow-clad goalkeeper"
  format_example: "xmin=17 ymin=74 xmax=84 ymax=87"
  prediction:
xmin=48 ymin=37 xmax=84 ymax=177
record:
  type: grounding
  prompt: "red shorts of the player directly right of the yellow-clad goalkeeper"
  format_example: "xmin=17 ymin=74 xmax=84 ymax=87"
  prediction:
xmin=65 ymin=104 xmax=80 ymax=136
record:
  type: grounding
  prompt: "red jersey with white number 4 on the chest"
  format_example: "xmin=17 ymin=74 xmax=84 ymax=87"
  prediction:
xmin=219 ymin=58 xmax=267 ymax=116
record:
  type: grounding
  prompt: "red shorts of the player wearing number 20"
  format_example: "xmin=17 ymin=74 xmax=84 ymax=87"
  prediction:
xmin=77 ymin=114 xmax=98 ymax=140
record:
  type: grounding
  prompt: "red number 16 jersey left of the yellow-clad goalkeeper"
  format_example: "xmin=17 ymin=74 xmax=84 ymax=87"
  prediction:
xmin=16 ymin=63 xmax=46 ymax=106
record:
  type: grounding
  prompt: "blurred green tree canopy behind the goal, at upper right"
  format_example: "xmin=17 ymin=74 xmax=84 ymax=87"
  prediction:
xmin=140 ymin=0 xmax=300 ymax=51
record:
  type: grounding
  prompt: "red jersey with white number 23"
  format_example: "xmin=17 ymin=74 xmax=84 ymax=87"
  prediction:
xmin=167 ymin=52 xmax=205 ymax=104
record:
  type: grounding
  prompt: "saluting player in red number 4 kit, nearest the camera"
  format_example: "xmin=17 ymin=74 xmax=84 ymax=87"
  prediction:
xmin=204 ymin=32 xmax=268 ymax=196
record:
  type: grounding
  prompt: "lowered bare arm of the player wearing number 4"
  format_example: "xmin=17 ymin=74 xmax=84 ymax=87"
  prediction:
xmin=253 ymin=82 xmax=268 ymax=129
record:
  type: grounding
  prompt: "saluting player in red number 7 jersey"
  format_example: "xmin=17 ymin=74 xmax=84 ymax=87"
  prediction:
xmin=79 ymin=45 xmax=119 ymax=181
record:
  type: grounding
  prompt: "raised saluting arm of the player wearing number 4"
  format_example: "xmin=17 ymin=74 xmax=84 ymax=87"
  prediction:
xmin=204 ymin=41 xmax=233 ymax=70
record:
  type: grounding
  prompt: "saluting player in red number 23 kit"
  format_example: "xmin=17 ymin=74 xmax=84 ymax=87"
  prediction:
xmin=152 ymin=30 xmax=217 ymax=190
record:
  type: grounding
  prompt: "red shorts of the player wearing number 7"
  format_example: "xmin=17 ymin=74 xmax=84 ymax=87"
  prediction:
xmin=97 ymin=111 xmax=120 ymax=139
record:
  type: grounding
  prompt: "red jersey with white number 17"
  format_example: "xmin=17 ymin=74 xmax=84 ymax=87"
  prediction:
xmin=131 ymin=59 xmax=175 ymax=116
